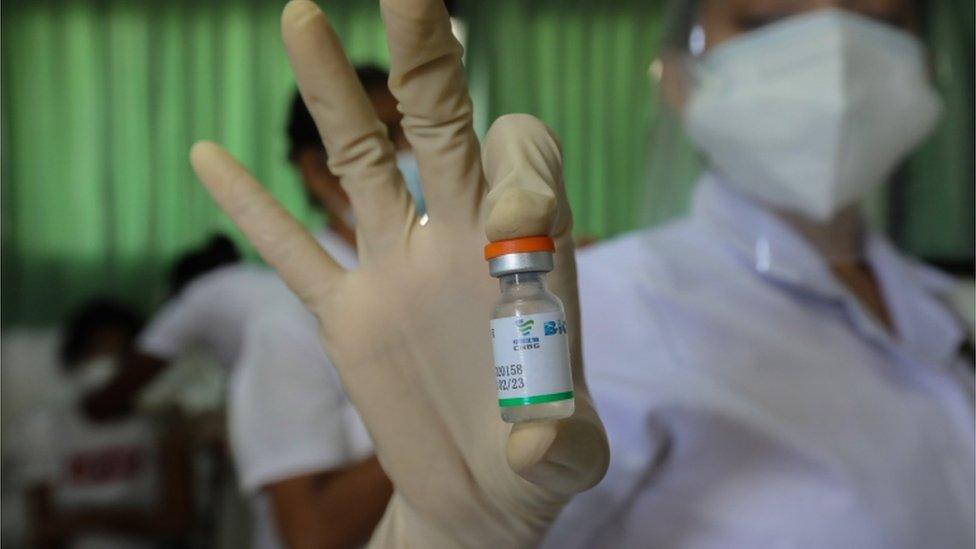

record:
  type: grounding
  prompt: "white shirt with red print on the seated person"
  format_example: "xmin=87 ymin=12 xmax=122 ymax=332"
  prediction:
xmin=17 ymin=403 xmax=160 ymax=549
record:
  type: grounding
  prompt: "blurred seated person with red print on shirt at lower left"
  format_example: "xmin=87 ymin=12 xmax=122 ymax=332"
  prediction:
xmin=18 ymin=300 xmax=193 ymax=548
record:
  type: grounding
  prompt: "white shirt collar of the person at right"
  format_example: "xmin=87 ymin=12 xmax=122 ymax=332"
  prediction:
xmin=692 ymin=174 xmax=965 ymax=363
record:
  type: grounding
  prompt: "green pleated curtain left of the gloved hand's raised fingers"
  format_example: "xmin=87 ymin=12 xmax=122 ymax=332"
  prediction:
xmin=2 ymin=0 xmax=388 ymax=325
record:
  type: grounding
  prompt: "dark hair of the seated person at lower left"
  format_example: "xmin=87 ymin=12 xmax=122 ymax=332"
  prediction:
xmin=60 ymin=297 xmax=143 ymax=366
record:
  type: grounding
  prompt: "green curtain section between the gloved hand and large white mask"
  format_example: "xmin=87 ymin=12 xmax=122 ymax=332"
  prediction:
xmin=466 ymin=0 xmax=663 ymax=237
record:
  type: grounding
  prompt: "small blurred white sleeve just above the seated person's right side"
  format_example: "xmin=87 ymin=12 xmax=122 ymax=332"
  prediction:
xmin=136 ymin=286 xmax=210 ymax=360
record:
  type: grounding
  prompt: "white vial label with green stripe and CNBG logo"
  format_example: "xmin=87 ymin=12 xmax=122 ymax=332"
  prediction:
xmin=491 ymin=312 xmax=573 ymax=408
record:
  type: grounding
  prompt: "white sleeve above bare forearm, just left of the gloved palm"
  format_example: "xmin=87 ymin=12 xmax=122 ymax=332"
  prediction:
xmin=229 ymin=306 xmax=363 ymax=492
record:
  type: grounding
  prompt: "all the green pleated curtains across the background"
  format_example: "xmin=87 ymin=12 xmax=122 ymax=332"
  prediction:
xmin=0 ymin=0 xmax=973 ymax=325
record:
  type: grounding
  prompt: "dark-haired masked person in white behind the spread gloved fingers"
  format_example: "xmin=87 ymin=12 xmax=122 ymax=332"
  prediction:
xmin=229 ymin=67 xmax=408 ymax=549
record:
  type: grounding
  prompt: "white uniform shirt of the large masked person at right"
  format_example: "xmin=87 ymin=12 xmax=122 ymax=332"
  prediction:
xmin=546 ymin=177 xmax=974 ymax=549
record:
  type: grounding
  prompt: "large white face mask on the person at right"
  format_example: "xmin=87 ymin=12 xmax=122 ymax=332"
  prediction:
xmin=684 ymin=9 xmax=942 ymax=221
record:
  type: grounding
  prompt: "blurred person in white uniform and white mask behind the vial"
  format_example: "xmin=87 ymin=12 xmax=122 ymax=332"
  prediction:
xmin=546 ymin=0 xmax=974 ymax=549
